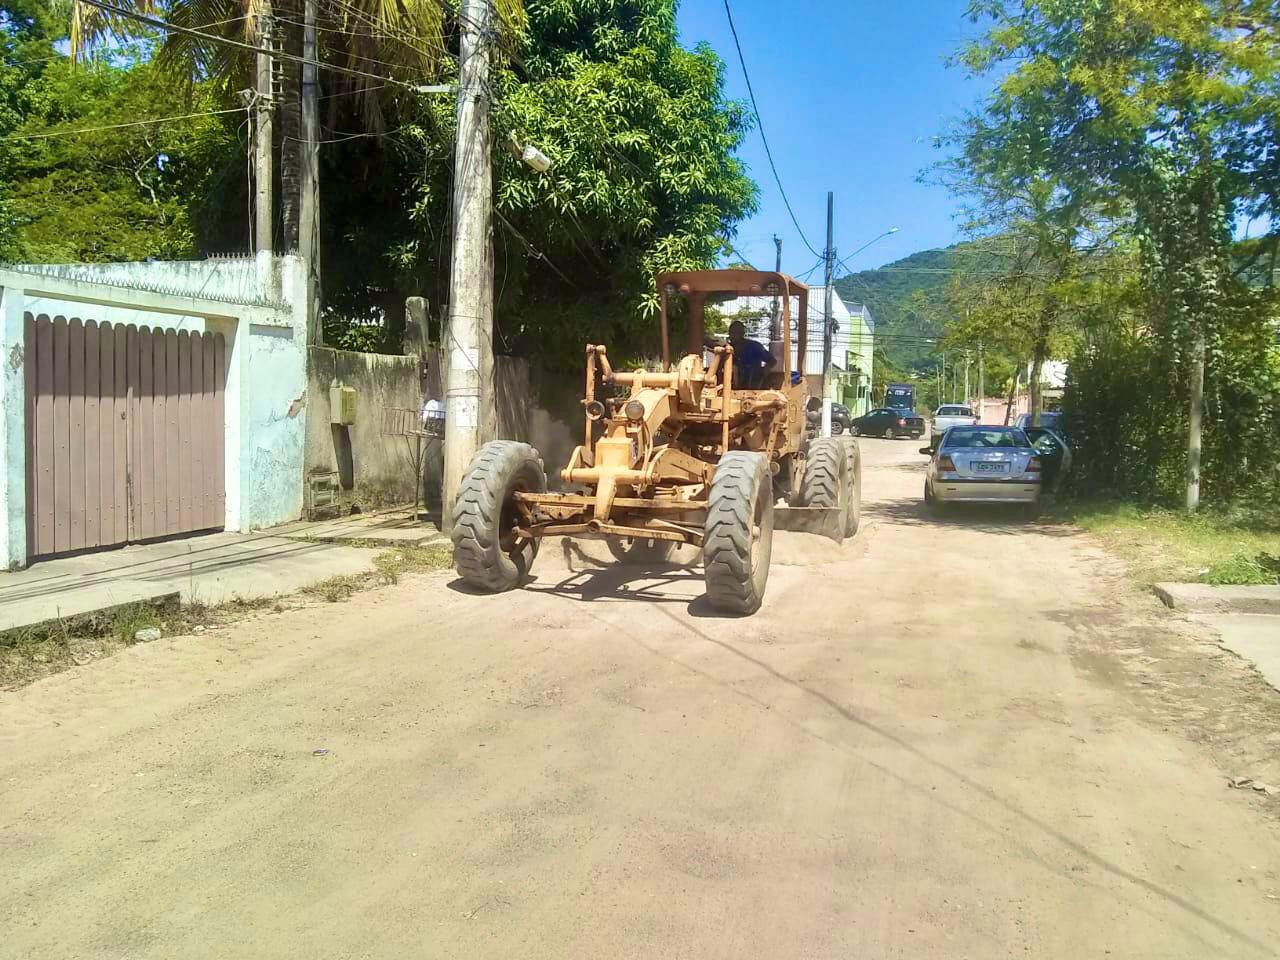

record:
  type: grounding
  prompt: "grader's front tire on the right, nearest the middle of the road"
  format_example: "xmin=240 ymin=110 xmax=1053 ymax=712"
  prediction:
xmin=703 ymin=451 xmax=773 ymax=614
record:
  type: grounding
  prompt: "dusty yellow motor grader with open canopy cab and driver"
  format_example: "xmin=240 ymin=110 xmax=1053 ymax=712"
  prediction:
xmin=452 ymin=270 xmax=861 ymax=614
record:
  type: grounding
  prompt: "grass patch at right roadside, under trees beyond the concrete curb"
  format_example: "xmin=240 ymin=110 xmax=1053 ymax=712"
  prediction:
xmin=1066 ymin=503 xmax=1280 ymax=586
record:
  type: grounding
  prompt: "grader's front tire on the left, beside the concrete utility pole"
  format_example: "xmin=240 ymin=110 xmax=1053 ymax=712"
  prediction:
xmin=449 ymin=440 xmax=547 ymax=593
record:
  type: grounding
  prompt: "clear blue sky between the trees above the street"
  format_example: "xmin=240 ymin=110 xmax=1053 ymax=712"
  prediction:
xmin=678 ymin=0 xmax=987 ymax=279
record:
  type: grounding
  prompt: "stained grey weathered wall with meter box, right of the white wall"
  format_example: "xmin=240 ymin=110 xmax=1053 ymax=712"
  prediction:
xmin=306 ymin=347 xmax=422 ymax=512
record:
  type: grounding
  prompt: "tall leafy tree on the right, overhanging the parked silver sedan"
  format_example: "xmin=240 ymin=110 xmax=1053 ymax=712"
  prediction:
xmin=950 ymin=0 xmax=1280 ymax=498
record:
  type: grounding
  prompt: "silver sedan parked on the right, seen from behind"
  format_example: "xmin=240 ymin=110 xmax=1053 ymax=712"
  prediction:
xmin=920 ymin=425 xmax=1043 ymax=517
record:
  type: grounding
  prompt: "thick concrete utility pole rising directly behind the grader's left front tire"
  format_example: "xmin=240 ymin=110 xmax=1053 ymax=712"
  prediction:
xmin=444 ymin=0 xmax=497 ymax=530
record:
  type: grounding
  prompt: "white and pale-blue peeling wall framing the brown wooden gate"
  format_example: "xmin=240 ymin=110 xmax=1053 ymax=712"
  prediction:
xmin=0 ymin=257 xmax=307 ymax=568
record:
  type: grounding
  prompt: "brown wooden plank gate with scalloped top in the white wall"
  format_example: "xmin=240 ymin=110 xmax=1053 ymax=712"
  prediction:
xmin=26 ymin=314 xmax=227 ymax=557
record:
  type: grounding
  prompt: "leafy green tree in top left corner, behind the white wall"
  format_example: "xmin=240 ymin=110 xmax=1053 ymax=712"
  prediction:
xmin=0 ymin=4 xmax=243 ymax=262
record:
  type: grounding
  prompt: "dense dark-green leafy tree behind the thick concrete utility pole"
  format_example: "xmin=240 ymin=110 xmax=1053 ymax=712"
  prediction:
xmin=305 ymin=0 xmax=756 ymax=365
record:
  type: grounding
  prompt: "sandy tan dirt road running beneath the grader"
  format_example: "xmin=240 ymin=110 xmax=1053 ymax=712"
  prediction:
xmin=0 ymin=440 xmax=1280 ymax=960
